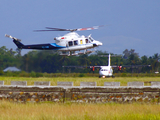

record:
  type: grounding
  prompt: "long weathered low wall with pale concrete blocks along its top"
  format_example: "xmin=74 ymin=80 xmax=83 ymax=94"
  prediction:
xmin=0 ymin=81 xmax=160 ymax=103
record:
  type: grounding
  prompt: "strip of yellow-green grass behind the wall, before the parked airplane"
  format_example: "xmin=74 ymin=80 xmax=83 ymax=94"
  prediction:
xmin=0 ymin=77 xmax=160 ymax=86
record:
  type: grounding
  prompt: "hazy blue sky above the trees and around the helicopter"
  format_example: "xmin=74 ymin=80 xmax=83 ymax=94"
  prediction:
xmin=0 ymin=0 xmax=160 ymax=57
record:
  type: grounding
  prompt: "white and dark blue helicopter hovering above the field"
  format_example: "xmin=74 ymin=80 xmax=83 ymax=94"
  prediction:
xmin=5 ymin=26 xmax=103 ymax=56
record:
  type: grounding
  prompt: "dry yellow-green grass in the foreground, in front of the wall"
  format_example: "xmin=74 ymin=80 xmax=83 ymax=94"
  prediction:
xmin=0 ymin=101 xmax=160 ymax=120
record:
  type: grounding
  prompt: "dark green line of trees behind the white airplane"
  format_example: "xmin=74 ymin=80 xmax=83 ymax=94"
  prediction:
xmin=0 ymin=46 xmax=160 ymax=73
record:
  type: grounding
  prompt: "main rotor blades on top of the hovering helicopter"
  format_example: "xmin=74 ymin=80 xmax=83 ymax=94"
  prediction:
xmin=34 ymin=25 xmax=104 ymax=32
